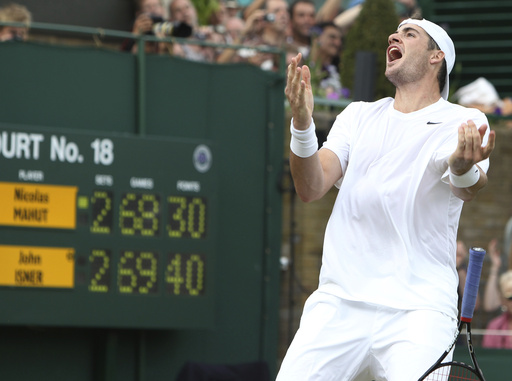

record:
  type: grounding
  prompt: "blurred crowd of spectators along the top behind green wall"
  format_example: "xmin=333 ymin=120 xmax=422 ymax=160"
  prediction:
xmin=0 ymin=0 xmax=421 ymax=99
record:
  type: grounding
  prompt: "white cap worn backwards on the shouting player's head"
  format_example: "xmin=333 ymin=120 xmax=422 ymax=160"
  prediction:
xmin=398 ymin=19 xmax=455 ymax=99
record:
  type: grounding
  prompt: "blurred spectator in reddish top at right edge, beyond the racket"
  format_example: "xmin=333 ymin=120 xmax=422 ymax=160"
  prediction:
xmin=482 ymin=270 xmax=512 ymax=349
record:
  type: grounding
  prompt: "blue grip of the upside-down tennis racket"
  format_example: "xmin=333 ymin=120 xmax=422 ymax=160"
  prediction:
xmin=460 ymin=247 xmax=485 ymax=322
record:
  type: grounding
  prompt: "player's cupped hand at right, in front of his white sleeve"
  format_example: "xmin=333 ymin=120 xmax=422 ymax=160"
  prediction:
xmin=448 ymin=120 xmax=496 ymax=176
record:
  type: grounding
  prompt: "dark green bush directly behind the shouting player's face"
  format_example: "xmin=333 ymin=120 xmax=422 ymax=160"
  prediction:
xmin=340 ymin=0 xmax=399 ymax=99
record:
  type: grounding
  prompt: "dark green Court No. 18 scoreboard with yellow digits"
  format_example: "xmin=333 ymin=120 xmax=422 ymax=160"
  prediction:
xmin=0 ymin=125 xmax=218 ymax=328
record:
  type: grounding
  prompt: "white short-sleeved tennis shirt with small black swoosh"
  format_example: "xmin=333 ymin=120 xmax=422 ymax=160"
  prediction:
xmin=319 ymin=98 xmax=489 ymax=318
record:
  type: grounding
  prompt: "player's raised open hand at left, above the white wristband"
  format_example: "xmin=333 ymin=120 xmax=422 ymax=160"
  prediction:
xmin=284 ymin=53 xmax=314 ymax=130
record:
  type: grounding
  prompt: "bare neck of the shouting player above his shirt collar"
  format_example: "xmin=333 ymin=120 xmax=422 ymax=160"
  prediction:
xmin=394 ymin=84 xmax=441 ymax=113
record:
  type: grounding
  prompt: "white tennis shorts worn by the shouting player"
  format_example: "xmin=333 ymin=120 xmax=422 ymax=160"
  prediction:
xmin=277 ymin=291 xmax=457 ymax=381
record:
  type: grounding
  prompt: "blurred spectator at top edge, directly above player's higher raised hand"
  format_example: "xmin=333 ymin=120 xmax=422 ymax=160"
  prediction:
xmin=288 ymin=0 xmax=315 ymax=59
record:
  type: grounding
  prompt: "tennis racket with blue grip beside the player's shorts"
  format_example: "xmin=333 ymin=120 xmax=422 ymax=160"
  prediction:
xmin=418 ymin=247 xmax=485 ymax=381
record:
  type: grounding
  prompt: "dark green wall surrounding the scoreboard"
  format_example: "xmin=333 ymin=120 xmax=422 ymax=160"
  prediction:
xmin=0 ymin=43 xmax=284 ymax=381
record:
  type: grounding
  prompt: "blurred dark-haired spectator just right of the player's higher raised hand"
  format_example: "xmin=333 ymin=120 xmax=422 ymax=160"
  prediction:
xmin=306 ymin=22 xmax=346 ymax=99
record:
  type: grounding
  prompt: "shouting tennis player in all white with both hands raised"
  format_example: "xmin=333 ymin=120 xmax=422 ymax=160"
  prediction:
xmin=277 ymin=19 xmax=495 ymax=381
